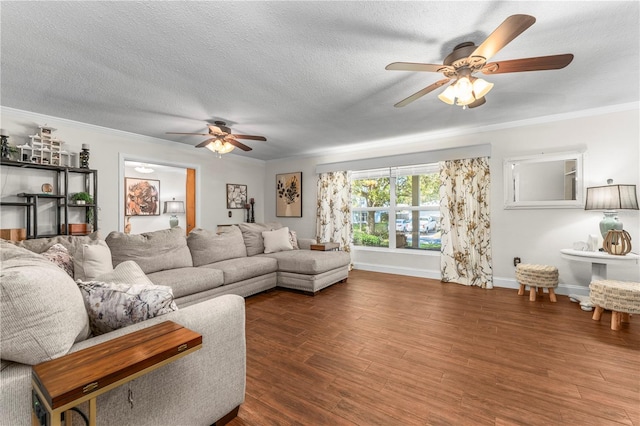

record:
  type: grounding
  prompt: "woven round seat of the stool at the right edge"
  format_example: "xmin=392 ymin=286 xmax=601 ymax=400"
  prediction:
xmin=589 ymin=280 xmax=640 ymax=314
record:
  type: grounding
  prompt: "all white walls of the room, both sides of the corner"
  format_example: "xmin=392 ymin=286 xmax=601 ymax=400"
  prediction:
xmin=0 ymin=104 xmax=640 ymax=292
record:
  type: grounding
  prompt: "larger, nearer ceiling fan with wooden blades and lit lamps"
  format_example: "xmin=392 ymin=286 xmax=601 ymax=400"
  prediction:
xmin=385 ymin=15 xmax=573 ymax=108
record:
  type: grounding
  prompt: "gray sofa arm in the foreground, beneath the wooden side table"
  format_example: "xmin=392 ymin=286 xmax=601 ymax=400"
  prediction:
xmin=67 ymin=295 xmax=246 ymax=425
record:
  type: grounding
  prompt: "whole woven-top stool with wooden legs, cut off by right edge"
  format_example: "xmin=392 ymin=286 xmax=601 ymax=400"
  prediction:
xmin=589 ymin=280 xmax=640 ymax=330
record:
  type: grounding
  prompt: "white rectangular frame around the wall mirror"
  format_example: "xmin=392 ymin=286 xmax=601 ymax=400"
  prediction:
xmin=503 ymin=151 xmax=584 ymax=209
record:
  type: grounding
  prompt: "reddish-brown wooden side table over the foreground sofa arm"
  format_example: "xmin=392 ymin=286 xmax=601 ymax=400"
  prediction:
xmin=32 ymin=321 xmax=202 ymax=426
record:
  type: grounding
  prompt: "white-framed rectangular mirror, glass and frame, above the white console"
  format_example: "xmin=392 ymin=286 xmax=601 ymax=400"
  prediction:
xmin=504 ymin=152 xmax=584 ymax=209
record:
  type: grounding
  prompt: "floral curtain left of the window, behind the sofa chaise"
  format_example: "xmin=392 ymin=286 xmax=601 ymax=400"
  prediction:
xmin=316 ymin=171 xmax=351 ymax=251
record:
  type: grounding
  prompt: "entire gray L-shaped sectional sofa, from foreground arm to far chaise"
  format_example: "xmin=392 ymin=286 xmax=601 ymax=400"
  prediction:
xmin=0 ymin=223 xmax=350 ymax=426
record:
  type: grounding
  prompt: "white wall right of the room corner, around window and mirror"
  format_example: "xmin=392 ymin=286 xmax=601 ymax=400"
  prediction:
xmin=265 ymin=104 xmax=640 ymax=294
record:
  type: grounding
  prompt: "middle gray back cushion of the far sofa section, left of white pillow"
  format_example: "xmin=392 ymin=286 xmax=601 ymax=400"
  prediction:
xmin=187 ymin=226 xmax=247 ymax=266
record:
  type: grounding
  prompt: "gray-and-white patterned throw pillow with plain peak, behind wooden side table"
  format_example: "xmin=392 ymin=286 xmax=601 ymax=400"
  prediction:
xmin=77 ymin=261 xmax=178 ymax=336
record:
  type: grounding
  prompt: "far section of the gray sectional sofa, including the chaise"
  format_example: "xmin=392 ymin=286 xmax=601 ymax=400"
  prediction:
xmin=105 ymin=223 xmax=351 ymax=307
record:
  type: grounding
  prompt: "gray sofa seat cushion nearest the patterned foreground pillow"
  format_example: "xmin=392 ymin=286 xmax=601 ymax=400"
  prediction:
xmin=147 ymin=267 xmax=224 ymax=299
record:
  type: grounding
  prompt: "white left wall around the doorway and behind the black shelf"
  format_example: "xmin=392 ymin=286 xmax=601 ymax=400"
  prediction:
xmin=0 ymin=107 xmax=265 ymax=236
